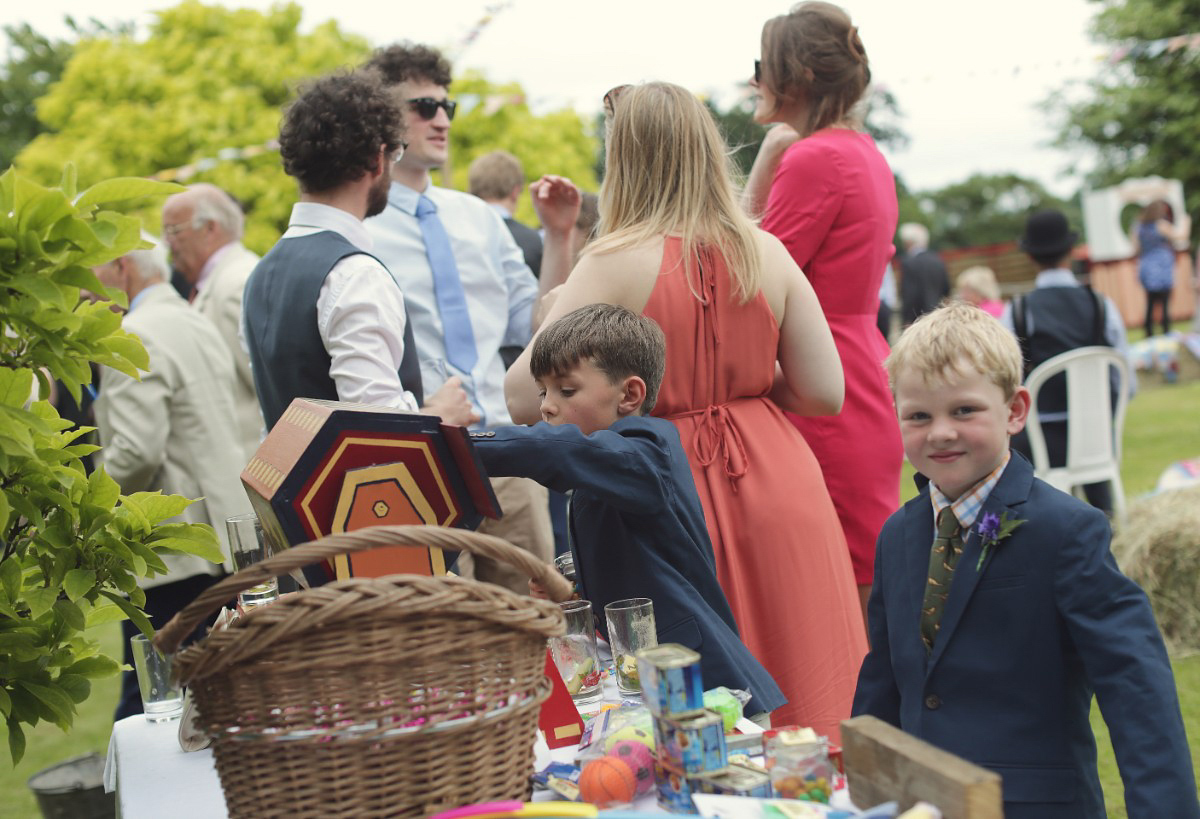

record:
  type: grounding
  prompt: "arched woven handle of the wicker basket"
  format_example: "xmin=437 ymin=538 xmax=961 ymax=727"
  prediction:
xmin=154 ymin=526 xmax=572 ymax=653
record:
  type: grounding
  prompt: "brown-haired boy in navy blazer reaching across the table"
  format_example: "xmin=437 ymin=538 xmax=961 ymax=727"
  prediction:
xmin=470 ymin=304 xmax=786 ymax=716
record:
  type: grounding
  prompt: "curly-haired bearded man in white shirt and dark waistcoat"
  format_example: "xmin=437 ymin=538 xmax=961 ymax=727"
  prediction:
xmin=244 ymin=71 xmax=474 ymax=429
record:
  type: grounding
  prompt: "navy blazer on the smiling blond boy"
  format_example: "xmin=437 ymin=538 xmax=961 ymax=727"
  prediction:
xmin=853 ymin=453 xmax=1200 ymax=819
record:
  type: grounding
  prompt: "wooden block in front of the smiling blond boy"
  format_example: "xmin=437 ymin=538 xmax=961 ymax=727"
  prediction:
xmin=841 ymin=716 xmax=1004 ymax=819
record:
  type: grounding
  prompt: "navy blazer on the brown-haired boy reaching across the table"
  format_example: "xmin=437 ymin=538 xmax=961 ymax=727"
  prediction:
xmin=472 ymin=417 xmax=787 ymax=715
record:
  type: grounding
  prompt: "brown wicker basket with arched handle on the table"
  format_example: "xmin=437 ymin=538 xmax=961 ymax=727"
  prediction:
xmin=156 ymin=526 xmax=570 ymax=819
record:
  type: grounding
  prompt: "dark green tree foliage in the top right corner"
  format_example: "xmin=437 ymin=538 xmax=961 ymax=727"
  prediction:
xmin=1046 ymin=0 xmax=1200 ymax=213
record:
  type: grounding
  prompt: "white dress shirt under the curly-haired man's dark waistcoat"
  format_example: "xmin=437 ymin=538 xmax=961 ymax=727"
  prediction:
xmin=280 ymin=202 xmax=418 ymax=412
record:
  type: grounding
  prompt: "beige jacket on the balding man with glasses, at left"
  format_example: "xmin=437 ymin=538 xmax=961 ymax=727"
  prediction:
xmin=192 ymin=244 xmax=264 ymax=465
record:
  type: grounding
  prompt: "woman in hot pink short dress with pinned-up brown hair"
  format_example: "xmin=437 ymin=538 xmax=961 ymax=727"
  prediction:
xmin=743 ymin=2 xmax=904 ymax=616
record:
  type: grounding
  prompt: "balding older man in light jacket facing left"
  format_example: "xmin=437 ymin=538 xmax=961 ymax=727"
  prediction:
xmin=162 ymin=184 xmax=263 ymax=464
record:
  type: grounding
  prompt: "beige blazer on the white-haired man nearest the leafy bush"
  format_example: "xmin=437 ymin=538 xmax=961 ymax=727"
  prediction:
xmin=96 ymin=283 xmax=251 ymax=588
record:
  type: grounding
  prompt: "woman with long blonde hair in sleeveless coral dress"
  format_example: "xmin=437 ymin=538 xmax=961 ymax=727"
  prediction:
xmin=505 ymin=83 xmax=866 ymax=737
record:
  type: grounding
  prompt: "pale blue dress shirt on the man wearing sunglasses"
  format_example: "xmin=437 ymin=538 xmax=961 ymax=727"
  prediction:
xmin=365 ymin=183 xmax=538 ymax=426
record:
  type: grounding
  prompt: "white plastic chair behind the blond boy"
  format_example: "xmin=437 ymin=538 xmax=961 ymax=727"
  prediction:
xmin=1025 ymin=347 xmax=1129 ymax=525
